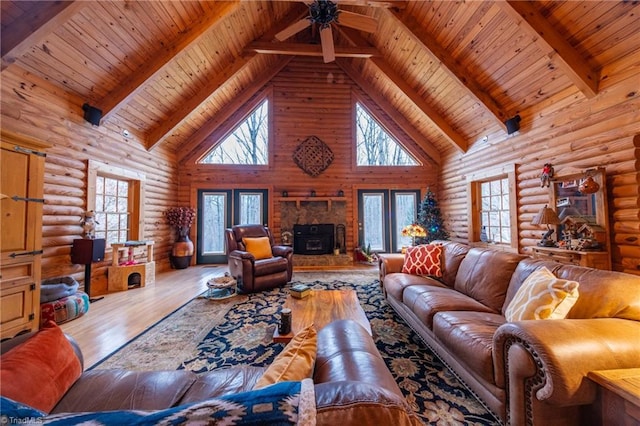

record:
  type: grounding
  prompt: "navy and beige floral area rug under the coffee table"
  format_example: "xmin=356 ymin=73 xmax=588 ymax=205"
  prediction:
xmin=94 ymin=271 xmax=498 ymax=425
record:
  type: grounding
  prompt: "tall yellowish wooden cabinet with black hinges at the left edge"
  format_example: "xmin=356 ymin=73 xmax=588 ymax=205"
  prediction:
xmin=0 ymin=130 xmax=48 ymax=339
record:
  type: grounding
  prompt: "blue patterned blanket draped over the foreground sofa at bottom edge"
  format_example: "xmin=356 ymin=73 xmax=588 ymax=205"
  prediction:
xmin=44 ymin=379 xmax=315 ymax=425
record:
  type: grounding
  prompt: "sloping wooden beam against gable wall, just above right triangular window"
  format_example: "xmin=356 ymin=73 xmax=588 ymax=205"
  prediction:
xmin=336 ymin=59 xmax=441 ymax=164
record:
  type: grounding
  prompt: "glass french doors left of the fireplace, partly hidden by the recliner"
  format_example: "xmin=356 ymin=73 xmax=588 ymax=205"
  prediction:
xmin=196 ymin=189 xmax=269 ymax=263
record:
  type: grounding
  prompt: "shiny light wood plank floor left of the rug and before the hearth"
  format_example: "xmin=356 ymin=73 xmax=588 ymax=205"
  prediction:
xmin=61 ymin=264 xmax=377 ymax=368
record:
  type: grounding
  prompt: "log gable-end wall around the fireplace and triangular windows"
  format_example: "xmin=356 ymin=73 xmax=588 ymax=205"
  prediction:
xmin=179 ymin=57 xmax=438 ymax=253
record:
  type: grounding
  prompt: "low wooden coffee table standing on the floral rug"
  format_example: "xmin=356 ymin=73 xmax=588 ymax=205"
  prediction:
xmin=273 ymin=290 xmax=371 ymax=343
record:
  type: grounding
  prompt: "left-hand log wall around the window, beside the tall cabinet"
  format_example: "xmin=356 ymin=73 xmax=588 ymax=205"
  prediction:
xmin=2 ymin=66 xmax=177 ymax=296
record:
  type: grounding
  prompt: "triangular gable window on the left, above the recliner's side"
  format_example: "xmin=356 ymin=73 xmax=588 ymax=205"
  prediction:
xmin=199 ymin=99 xmax=269 ymax=165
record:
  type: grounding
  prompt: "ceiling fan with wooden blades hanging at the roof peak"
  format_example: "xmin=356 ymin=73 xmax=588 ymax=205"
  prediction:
xmin=275 ymin=0 xmax=378 ymax=63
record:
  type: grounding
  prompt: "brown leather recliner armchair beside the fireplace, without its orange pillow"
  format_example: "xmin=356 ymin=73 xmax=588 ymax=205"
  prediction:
xmin=225 ymin=225 xmax=293 ymax=293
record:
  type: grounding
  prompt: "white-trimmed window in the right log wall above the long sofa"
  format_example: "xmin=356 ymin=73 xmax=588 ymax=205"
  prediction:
xmin=469 ymin=166 xmax=518 ymax=250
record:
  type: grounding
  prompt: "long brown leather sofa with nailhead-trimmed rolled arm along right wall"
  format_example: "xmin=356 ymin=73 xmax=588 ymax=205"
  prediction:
xmin=379 ymin=242 xmax=640 ymax=426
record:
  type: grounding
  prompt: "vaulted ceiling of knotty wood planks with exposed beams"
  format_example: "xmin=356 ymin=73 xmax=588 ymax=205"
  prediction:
xmin=0 ymin=0 xmax=640 ymax=163
